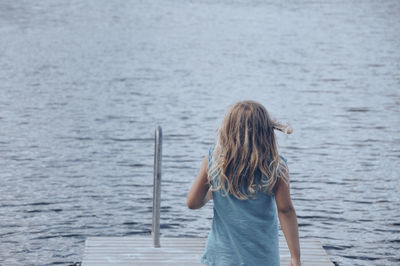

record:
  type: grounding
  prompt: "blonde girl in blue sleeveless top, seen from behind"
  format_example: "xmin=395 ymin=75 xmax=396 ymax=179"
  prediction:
xmin=187 ymin=101 xmax=300 ymax=266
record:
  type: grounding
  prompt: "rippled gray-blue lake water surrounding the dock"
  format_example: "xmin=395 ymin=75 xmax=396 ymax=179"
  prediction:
xmin=0 ymin=0 xmax=400 ymax=265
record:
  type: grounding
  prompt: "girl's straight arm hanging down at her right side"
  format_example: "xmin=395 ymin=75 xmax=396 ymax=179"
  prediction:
xmin=275 ymin=167 xmax=300 ymax=266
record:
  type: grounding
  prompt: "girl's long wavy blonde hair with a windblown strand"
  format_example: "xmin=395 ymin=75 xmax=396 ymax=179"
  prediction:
xmin=208 ymin=101 xmax=292 ymax=200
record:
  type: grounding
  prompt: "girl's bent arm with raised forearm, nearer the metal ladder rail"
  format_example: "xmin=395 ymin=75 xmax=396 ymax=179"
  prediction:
xmin=186 ymin=156 xmax=212 ymax=209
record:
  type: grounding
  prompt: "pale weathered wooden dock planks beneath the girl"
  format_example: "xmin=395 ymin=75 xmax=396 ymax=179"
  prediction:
xmin=82 ymin=236 xmax=333 ymax=266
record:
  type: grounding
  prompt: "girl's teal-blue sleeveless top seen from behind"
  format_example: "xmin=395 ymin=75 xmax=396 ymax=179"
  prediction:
xmin=201 ymin=147 xmax=286 ymax=266
